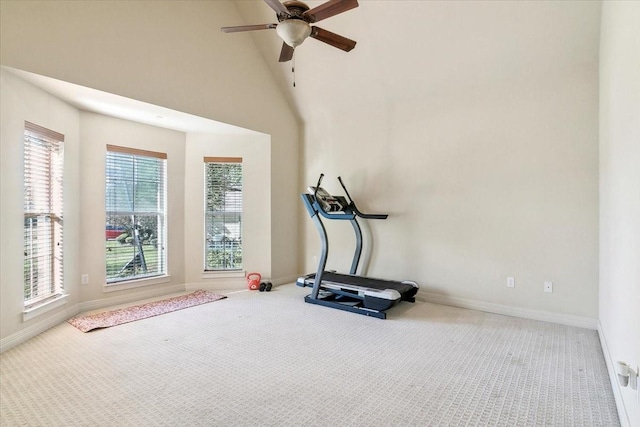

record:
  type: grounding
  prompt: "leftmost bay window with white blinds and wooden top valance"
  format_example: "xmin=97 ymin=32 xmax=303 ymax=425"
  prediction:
xmin=24 ymin=122 xmax=64 ymax=307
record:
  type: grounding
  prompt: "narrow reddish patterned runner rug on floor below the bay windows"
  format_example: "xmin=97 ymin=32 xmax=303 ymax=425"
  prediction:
xmin=67 ymin=290 xmax=226 ymax=332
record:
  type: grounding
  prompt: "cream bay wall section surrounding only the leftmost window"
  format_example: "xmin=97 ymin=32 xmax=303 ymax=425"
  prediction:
xmin=0 ymin=70 xmax=81 ymax=338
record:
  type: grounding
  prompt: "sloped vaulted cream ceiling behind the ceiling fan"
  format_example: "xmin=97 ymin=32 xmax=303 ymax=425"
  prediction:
xmin=234 ymin=0 xmax=600 ymax=120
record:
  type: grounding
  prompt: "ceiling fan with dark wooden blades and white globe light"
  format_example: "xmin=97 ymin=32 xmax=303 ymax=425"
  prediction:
xmin=221 ymin=0 xmax=358 ymax=62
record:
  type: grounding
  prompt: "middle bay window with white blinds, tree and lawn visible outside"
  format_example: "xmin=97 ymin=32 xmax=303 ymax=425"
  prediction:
xmin=105 ymin=145 xmax=167 ymax=284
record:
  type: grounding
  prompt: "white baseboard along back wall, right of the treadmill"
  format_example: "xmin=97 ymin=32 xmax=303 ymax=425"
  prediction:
xmin=416 ymin=292 xmax=598 ymax=330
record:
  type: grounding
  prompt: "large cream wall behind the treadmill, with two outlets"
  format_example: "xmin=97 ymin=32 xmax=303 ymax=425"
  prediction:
xmin=301 ymin=49 xmax=598 ymax=324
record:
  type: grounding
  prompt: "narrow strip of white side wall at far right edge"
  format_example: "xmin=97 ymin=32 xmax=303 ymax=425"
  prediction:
xmin=600 ymin=1 xmax=640 ymax=426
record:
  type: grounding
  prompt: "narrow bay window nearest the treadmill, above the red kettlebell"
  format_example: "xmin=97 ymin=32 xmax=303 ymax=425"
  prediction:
xmin=204 ymin=157 xmax=242 ymax=271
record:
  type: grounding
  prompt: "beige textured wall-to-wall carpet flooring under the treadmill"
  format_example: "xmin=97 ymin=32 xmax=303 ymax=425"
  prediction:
xmin=0 ymin=285 xmax=619 ymax=427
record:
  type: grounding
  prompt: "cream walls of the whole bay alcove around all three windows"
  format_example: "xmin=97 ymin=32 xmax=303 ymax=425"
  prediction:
xmin=0 ymin=68 xmax=273 ymax=347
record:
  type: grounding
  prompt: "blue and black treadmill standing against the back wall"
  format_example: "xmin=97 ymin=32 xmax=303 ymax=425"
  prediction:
xmin=296 ymin=174 xmax=419 ymax=319
